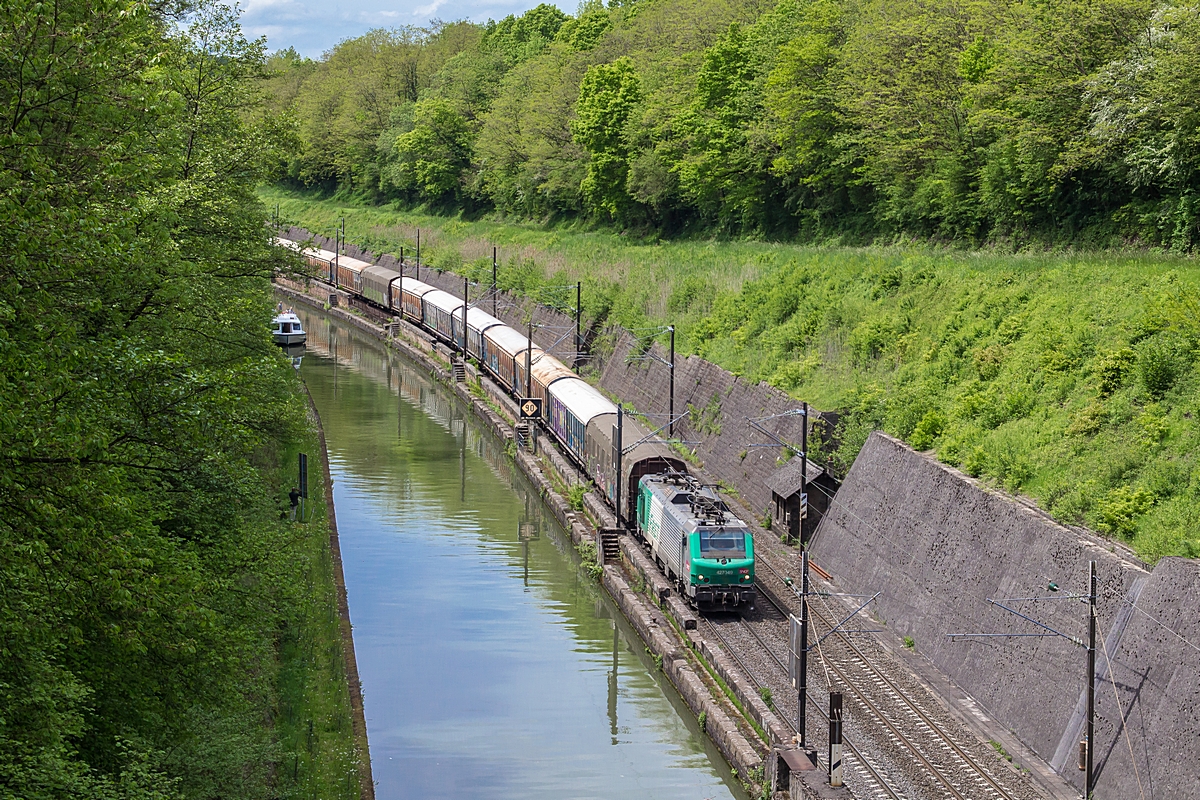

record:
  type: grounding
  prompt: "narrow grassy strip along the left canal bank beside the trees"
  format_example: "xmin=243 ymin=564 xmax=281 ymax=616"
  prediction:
xmin=275 ymin=400 xmax=366 ymax=800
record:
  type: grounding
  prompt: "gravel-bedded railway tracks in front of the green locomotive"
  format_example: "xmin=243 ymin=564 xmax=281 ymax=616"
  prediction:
xmin=726 ymin=558 xmax=1040 ymax=800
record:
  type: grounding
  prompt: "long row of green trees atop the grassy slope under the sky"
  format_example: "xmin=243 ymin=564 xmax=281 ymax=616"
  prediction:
xmin=268 ymin=0 xmax=1200 ymax=251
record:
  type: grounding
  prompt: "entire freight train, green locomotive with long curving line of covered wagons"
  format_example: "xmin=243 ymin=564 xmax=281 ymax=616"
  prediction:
xmin=276 ymin=239 xmax=756 ymax=610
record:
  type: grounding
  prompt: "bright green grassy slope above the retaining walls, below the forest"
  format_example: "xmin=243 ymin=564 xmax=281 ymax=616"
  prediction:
xmin=263 ymin=190 xmax=1200 ymax=560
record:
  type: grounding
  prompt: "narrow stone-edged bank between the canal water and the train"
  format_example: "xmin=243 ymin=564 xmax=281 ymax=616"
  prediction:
xmin=284 ymin=288 xmax=779 ymax=792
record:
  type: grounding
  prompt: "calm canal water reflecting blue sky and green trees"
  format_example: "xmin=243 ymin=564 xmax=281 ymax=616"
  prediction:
xmin=301 ymin=312 xmax=744 ymax=800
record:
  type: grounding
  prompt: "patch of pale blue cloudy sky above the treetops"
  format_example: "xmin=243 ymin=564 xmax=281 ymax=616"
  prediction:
xmin=241 ymin=0 xmax=564 ymax=59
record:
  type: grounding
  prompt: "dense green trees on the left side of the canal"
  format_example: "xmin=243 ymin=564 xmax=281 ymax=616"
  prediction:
xmin=0 ymin=0 xmax=358 ymax=800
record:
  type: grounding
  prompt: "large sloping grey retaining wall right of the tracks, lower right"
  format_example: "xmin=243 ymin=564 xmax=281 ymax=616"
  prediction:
xmin=812 ymin=433 xmax=1200 ymax=798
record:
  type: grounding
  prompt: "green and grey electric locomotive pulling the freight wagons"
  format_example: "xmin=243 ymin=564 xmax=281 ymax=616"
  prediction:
xmin=637 ymin=473 xmax=757 ymax=610
